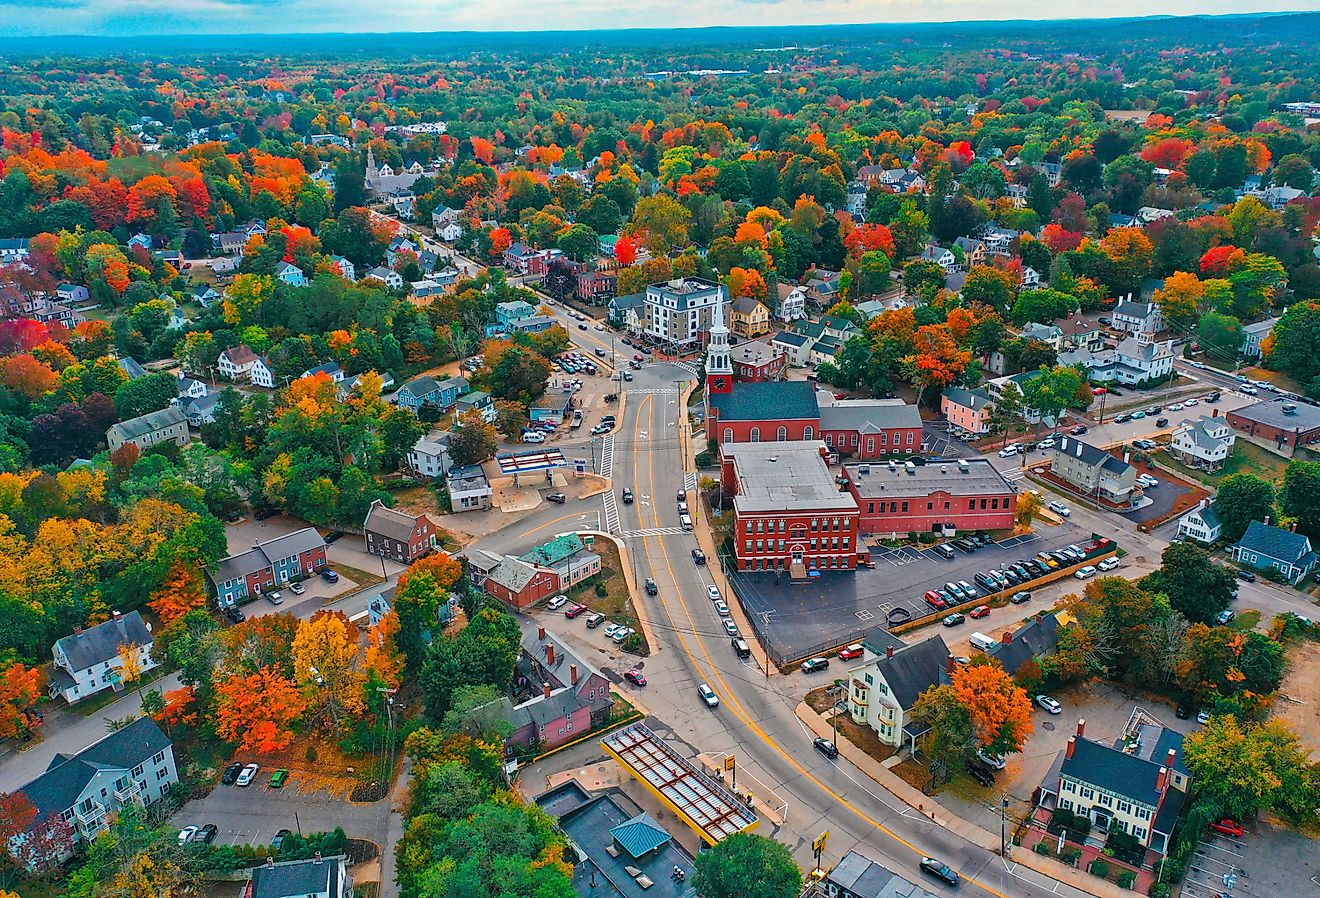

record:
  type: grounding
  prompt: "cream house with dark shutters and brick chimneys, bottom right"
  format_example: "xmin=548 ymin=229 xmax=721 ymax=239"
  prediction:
xmin=1039 ymin=720 xmax=1191 ymax=854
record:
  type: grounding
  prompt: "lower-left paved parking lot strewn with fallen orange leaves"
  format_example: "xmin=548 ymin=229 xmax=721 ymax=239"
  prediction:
xmin=172 ymin=767 xmax=391 ymax=845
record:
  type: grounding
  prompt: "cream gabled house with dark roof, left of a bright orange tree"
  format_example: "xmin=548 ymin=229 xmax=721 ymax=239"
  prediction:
xmin=847 ymin=637 xmax=953 ymax=753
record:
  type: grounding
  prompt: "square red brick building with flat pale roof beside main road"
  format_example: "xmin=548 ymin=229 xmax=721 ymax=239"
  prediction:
xmin=719 ymin=440 xmax=859 ymax=577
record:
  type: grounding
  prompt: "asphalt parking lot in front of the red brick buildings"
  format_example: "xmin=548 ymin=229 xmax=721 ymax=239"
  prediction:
xmin=731 ymin=522 xmax=1089 ymax=658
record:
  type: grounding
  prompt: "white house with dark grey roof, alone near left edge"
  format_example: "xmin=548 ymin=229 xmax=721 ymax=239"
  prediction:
xmin=49 ymin=611 xmax=157 ymax=704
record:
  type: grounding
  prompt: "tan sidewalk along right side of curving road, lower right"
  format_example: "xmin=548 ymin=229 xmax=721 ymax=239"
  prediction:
xmin=793 ymin=703 xmax=1134 ymax=898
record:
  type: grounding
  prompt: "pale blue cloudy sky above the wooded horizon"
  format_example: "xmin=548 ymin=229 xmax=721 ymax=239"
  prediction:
xmin=0 ymin=0 xmax=1315 ymax=37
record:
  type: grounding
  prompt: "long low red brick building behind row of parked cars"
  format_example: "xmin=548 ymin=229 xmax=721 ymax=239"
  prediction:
xmin=843 ymin=458 xmax=1018 ymax=535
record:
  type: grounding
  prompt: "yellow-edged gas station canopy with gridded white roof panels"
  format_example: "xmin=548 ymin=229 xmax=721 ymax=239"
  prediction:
xmin=601 ymin=724 xmax=760 ymax=845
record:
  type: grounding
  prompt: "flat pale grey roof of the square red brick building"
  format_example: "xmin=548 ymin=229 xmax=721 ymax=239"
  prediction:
xmin=719 ymin=440 xmax=857 ymax=512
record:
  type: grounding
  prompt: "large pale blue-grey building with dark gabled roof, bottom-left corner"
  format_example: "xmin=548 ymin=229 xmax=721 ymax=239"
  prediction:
xmin=11 ymin=717 xmax=178 ymax=866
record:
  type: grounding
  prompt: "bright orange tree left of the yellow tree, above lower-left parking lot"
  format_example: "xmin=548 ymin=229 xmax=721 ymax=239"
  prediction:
xmin=215 ymin=667 xmax=308 ymax=753
